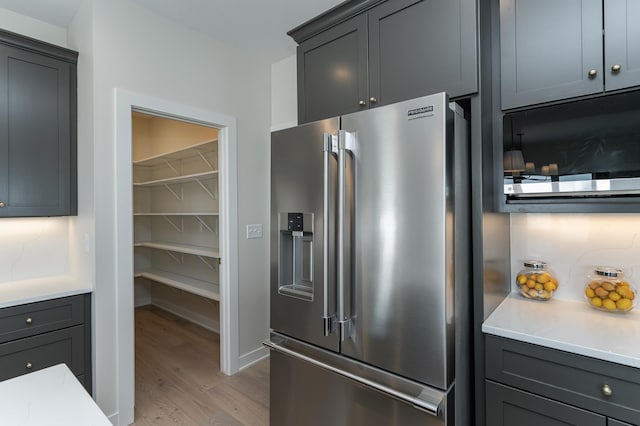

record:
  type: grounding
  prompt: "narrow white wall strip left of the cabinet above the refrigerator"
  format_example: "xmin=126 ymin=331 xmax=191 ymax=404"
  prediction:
xmin=271 ymin=55 xmax=298 ymax=131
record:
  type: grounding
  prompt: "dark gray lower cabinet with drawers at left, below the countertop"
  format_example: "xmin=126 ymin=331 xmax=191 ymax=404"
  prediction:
xmin=0 ymin=294 xmax=92 ymax=393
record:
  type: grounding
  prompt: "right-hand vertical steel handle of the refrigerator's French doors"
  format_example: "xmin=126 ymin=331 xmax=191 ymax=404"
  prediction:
xmin=338 ymin=130 xmax=355 ymax=342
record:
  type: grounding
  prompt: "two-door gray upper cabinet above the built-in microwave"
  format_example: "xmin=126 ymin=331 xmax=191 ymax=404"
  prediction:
xmin=500 ymin=0 xmax=640 ymax=109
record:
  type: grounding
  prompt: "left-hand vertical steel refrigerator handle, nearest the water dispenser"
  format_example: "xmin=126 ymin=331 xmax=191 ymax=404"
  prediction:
xmin=322 ymin=133 xmax=338 ymax=336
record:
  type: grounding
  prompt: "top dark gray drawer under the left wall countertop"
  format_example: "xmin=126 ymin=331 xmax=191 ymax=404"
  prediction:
xmin=0 ymin=295 xmax=84 ymax=343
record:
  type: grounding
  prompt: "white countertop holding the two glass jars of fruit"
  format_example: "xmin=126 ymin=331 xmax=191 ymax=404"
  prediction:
xmin=482 ymin=293 xmax=640 ymax=368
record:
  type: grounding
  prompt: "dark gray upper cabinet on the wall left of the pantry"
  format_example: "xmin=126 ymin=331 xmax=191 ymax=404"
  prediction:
xmin=0 ymin=32 xmax=77 ymax=217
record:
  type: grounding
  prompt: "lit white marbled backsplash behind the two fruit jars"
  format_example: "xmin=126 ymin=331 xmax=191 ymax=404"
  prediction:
xmin=511 ymin=213 xmax=640 ymax=301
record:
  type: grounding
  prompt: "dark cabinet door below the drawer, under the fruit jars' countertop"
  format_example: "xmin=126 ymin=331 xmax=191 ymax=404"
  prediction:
xmin=486 ymin=380 xmax=607 ymax=426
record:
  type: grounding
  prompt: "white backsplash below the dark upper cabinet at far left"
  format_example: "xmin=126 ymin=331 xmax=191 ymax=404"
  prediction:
xmin=0 ymin=217 xmax=69 ymax=285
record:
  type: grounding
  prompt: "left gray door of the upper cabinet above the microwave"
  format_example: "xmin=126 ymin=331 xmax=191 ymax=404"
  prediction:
xmin=500 ymin=0 xmax=604 ymax=109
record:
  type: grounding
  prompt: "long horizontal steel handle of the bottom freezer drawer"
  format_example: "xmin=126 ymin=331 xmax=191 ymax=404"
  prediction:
xmin=263 ymin=340 xmax=444 ymax=417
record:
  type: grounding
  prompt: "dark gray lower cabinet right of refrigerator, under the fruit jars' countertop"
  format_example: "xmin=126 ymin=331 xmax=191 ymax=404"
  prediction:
xmin=485 ymin=335 xmax=640 ymax=426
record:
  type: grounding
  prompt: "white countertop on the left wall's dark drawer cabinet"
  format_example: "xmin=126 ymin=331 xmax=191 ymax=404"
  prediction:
xmin=0 ymin=276 xmax=93 ymax=308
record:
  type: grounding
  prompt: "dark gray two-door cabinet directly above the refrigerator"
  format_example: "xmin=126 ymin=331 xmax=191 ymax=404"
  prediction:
xmin=289 ymin=0 xmax=478 ymax=123
